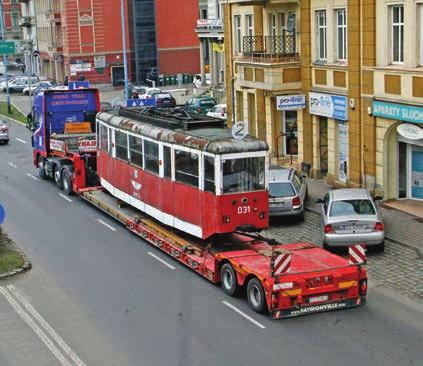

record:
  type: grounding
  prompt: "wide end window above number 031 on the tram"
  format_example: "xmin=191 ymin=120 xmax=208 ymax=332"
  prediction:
xmin=222 ymin=157 xmax=265 ymax=193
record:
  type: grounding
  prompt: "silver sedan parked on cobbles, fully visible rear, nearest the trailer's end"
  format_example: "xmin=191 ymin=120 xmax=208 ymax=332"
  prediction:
xmin=317 ymin=188 xmax=385 ymax=251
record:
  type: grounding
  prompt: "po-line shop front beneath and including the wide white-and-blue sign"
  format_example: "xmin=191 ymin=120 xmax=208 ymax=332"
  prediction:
xmin=309 ymin=92 xmax=349 ymax=184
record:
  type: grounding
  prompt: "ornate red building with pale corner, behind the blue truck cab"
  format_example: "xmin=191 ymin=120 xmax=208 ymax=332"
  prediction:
xmin=27 ymin=0 xmax=130 ymax=85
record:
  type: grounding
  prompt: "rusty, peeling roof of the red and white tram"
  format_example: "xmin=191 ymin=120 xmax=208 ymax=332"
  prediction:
xmin=97 ymin=111 xmax=268 ymax=154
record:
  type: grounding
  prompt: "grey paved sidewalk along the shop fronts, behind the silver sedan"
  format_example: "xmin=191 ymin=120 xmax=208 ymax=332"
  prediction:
xmin=306 ymin=179 xmax=423 ymax=253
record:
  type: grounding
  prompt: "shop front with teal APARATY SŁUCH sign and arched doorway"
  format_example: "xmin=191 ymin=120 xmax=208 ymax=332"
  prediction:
xmin=372 ymin=100 xmax=423 ymax=200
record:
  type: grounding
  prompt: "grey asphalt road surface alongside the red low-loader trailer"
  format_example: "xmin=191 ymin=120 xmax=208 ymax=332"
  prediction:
xmin=0 ymin=121 xmax=423 ymax=366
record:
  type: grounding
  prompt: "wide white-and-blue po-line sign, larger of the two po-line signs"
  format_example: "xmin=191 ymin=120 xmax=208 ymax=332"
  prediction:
xmin=309 ymin=93 xmax=348 ymax=121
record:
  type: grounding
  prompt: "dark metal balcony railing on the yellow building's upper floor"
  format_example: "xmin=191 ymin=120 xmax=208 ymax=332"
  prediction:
xmin=242 ymin=30 xmax=299 ymax=62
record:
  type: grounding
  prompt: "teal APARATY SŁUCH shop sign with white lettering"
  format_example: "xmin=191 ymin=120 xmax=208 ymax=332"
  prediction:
xmin=372 ymin=100 xmax=423 ymax=123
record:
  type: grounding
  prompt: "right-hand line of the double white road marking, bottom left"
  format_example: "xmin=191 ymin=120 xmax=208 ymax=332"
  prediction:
xmin=7 ymin=285 xmax=86 ymax=366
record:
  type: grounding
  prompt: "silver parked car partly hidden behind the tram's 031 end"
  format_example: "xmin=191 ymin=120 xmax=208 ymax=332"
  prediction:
xmin=269 ymin=168 xmax=308 ymax=221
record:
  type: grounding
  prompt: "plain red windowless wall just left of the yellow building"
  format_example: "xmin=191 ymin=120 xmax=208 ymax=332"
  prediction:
xmin=156 ymin=0 xmax=200 ymax=75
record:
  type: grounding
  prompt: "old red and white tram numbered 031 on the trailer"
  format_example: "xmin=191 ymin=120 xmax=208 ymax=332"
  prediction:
xmin=97 ymin=109 xmax=268 ymax=239
